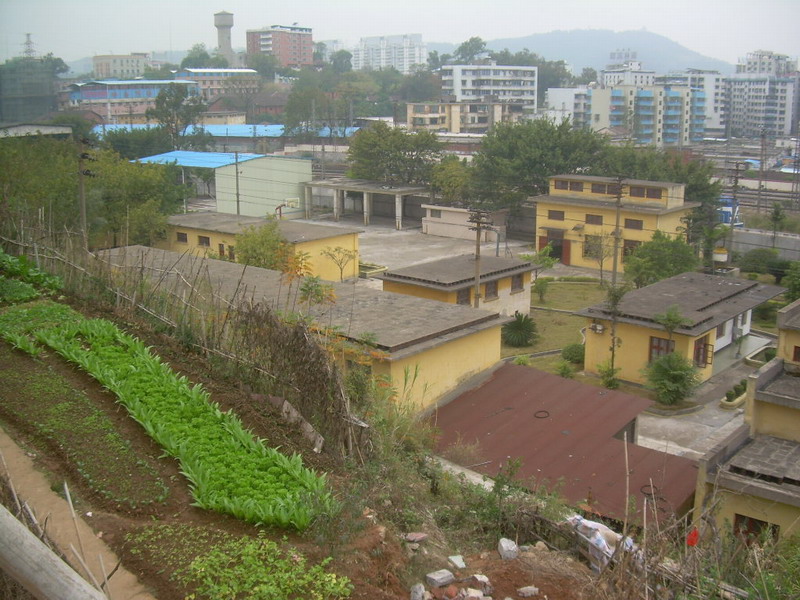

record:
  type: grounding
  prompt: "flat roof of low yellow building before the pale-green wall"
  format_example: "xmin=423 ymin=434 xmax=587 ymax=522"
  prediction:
xmin=167 ymin=212 xmax=362 ymax=244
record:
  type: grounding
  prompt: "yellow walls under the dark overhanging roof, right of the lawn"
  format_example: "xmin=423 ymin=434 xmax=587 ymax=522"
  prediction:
xmin=584 ymin=319 xmax=716 ymax=384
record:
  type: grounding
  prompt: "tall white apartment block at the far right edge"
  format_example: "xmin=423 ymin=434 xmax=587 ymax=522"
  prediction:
xmin=726 ymin=50 xmax=800 ymax=138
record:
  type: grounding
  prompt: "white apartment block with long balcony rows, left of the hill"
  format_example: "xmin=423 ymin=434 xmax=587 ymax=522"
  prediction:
xmin=441 ymin=61 xmax=539 ymax=111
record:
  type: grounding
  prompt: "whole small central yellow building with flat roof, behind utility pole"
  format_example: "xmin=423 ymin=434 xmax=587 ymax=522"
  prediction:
xmin=377 ymin=254 xmax=534 ymax=315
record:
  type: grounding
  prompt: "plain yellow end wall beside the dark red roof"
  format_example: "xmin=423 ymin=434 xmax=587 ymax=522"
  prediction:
xmin=372 ymin=325 xmax=500 ymax=411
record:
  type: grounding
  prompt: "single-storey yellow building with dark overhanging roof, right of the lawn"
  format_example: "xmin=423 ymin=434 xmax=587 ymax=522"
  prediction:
xmin=578 ymin=273 xmax=783 ymax=384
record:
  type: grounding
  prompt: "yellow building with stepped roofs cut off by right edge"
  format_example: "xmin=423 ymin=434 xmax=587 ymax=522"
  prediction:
xmin=695 ymin=300 xmax=800 ymax=536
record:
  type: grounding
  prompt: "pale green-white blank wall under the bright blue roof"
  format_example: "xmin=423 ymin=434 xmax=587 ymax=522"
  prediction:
xmin=215 ymin=156 xmax=311 ymax=219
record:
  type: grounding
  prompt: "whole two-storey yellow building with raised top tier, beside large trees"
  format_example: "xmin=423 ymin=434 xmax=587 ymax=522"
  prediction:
xmin=531 ymin=175 xmax=699 ymax=272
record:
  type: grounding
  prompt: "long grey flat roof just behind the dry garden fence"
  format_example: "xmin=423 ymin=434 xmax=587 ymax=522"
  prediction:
xmin=97 ymin=246 xmax=510 ymax=359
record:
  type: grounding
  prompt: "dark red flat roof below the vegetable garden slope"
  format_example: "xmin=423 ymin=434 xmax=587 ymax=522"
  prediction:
xmin=431 ymin=365 xmax=697 ymax=519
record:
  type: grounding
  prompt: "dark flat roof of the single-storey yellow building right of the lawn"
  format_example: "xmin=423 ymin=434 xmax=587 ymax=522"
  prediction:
xmin=577 ymin=272 xmax=784 ymax=336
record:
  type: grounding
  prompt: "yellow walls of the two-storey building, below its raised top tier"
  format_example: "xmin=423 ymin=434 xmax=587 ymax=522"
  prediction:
xmin=536 ymin=199 xmax=691 ymax=272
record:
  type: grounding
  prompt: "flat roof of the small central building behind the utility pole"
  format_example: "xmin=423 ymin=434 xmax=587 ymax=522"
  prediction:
xmin=376 ymin=254 xmax=535 ymax=290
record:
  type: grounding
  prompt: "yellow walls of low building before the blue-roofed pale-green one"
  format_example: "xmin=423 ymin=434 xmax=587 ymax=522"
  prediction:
xmin=156 ymin=225 xmax=358 ymax=281
